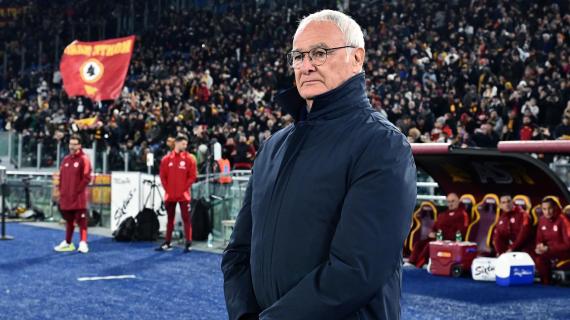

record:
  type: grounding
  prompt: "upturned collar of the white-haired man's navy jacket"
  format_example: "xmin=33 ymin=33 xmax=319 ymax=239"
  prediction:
xmin=275 ymin=72 xmax=368 ymax=121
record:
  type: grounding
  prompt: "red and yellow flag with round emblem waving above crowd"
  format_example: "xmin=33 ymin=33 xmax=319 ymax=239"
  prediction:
xmin=59 ymin=36 xmax=135 ymax=101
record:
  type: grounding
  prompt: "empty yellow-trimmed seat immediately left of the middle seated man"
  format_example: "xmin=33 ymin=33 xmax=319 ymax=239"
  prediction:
xmin=465 ymin=193 xmax=499 ymax=255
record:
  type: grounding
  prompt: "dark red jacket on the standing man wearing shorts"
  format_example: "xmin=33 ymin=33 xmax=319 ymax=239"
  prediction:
xmin=59 ymin=150 xmax=91 ymax=210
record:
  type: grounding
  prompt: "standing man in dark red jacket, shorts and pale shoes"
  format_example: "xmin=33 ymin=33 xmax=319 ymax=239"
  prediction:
xmin=54 ymin=135 xmax=91 ymax=253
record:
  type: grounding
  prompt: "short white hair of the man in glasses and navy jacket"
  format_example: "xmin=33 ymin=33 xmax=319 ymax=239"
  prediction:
xmin=293 ymin=10 xmax=364 ymax=49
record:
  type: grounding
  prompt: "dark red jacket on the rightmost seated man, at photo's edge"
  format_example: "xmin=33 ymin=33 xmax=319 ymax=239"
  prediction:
xmin=536 ymin=209 xmax=570 ymax=256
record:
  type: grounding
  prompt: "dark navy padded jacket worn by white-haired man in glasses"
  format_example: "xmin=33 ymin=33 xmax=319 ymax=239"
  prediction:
xmin=222 ymin=73 xmax=416 ymax=320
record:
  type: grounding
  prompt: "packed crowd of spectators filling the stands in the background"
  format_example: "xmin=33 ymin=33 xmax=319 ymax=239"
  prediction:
xmin=0 ymin=0 xmax=570 ymax=170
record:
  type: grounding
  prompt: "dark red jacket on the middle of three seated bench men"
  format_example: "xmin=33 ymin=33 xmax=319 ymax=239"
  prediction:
xmin=493 ymin=206 xmax=532 ymax=253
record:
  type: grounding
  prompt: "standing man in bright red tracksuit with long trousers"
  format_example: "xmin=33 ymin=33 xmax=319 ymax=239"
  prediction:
xmin=156 ymin=135 xmax=197 ymax=252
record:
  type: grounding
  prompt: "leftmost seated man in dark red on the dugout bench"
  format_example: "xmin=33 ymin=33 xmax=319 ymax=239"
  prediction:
xmin=405 ymin=192 xmax=469 ymax=268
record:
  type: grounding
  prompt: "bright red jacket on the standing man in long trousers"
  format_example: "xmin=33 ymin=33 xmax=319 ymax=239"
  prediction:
xmin=160 ymin=151 xmax=196 ymax=202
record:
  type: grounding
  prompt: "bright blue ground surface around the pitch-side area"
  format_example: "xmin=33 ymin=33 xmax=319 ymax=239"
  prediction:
xmin=0 ymin=223 xmax=570 ymax=320
